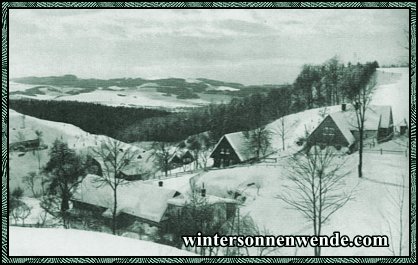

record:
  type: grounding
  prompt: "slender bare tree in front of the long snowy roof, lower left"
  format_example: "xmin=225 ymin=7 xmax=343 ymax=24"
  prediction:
xmin=92 ymin=139 xmax=138 ymax=234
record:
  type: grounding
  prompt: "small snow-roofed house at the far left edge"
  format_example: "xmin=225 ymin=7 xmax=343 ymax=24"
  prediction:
xmin=9 ymin=129 xmax=40 ymax=151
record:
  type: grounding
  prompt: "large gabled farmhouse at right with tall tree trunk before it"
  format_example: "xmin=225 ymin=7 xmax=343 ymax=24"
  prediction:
xmin=307 ymin=104 xmax=393 ymax=151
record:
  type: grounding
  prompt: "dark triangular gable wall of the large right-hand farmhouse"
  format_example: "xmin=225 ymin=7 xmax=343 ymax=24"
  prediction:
xmin=307 ymin=116 xmax=348 ymax=147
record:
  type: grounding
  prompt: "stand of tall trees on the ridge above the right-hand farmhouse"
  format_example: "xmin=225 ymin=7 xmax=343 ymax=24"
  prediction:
xmin=293 ymin=57 xmax=379 ymax=110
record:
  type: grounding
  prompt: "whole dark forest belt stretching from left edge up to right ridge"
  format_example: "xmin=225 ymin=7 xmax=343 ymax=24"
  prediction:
xmin=10 ymin=57 xmax=378 ymax=142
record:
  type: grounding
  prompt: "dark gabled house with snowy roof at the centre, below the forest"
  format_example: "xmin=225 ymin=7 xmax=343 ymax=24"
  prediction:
xmin=210 ymin=132 xmax=256 ymax=167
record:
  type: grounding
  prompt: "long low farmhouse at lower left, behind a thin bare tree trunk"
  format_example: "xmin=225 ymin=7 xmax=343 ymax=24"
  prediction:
xmin=72 ymin=174 xmax=180 ymax=227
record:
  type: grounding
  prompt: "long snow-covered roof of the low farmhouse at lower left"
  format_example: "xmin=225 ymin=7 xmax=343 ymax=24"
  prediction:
xmin=73 ymin=174 xmax=177 ymax=223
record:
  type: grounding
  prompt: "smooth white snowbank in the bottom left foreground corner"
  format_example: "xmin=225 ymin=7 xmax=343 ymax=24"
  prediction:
xmin=9 ymin=226 xmax=196 ymax=256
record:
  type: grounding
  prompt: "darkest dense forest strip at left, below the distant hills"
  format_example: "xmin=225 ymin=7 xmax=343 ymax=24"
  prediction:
xmin=9 ymin=99 xmax=169 ymax=137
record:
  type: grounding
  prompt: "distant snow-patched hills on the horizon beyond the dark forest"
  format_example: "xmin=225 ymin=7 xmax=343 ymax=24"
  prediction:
xmin=9 ymin=75 xmax=280 ymax=108
